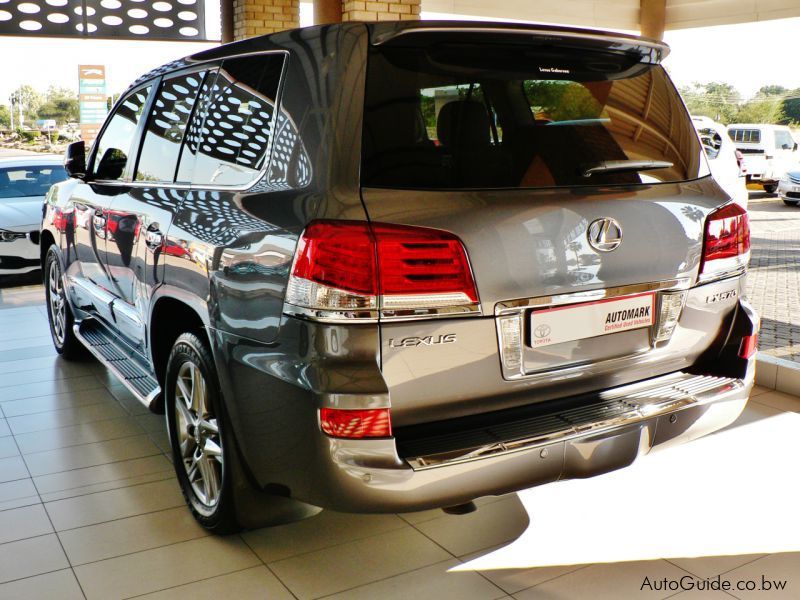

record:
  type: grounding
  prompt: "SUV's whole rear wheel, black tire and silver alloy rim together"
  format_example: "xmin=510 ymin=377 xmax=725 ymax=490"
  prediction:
xmin=164 ymin=333 xmax=241 ymax=535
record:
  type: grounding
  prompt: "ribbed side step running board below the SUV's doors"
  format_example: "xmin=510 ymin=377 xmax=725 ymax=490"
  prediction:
xmin=73 ymin=319 xmax=161 ymax=409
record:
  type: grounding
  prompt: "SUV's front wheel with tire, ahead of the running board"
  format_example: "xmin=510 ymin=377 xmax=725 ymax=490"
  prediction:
xmin=44 ymin=246 xmax=87 ymax=360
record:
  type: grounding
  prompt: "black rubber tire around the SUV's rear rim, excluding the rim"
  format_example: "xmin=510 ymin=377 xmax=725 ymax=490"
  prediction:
xmin=164 ymin=333 xmax=240 ymax=534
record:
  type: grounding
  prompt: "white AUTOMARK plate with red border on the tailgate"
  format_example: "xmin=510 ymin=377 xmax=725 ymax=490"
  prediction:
xmin=529 ymin=293 xmax=656 ymax=348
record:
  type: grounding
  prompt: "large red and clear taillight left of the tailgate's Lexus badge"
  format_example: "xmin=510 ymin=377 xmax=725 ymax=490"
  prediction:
xmin=286 ymin=221 xmax=478 ymax=314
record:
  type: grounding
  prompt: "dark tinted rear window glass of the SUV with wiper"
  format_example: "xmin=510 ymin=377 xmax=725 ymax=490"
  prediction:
xmin=361 ymin=45 xmax=707 ymax=189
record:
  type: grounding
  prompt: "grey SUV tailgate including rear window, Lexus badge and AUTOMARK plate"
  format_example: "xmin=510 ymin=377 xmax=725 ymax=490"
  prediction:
xmin=362 ymin=35 xmax=726 ymax=424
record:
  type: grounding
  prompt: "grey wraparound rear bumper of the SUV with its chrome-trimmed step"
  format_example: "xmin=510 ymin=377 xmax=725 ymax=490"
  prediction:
xmin=222 ymin=298 xmax=758 ymax=512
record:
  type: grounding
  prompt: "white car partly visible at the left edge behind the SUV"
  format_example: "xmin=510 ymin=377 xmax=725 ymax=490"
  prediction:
xmin=0 ymin=155 xmax=67 ymax=275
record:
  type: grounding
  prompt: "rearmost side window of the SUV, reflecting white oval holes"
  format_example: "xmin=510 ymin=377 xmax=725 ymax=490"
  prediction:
xmin=179 ymin=54 xmax=284 ymax=186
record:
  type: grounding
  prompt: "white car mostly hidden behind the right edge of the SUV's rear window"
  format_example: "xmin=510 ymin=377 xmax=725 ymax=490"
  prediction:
xmin=692 ymin=117 xmax=748 ymax=209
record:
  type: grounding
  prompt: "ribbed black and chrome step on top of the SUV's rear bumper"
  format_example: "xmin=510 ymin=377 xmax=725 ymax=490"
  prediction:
xmin=396 ymin=372 xmax=745 ymax=470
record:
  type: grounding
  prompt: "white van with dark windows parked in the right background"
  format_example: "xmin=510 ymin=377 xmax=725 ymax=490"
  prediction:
xmin=728 ymin=123 xmax=800 ymax=194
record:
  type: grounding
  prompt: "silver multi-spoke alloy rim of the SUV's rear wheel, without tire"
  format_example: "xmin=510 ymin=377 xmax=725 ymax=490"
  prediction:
xmin=175 ymin=361 xmax=223 ymax=509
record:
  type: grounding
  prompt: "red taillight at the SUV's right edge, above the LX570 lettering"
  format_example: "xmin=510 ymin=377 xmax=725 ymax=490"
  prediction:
xmin=700 ymin=204 xmax=750 ymax=276
